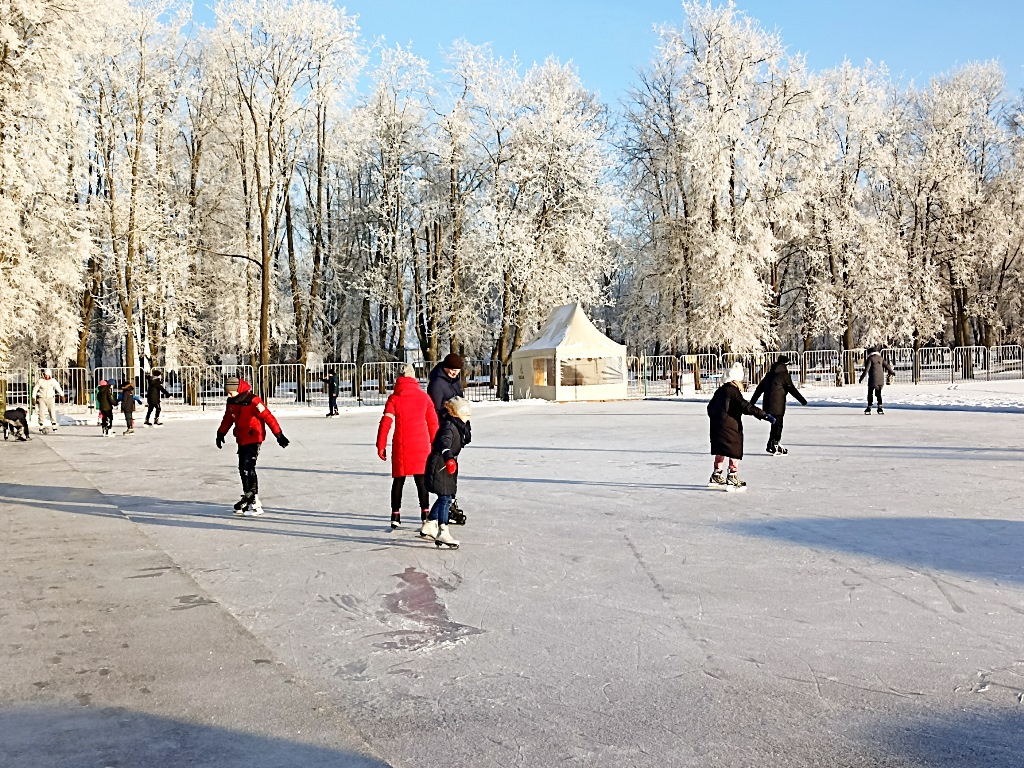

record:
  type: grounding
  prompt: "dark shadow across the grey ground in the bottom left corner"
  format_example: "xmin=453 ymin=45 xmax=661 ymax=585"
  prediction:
xmin=0 ymin=707 xmax=388 ymax=768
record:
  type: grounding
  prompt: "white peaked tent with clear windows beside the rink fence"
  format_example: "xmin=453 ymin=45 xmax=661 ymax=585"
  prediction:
xmin=512 ymin=304 xmax=627 ymax=400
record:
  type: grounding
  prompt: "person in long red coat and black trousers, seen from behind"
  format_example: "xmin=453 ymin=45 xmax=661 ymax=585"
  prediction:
xmin=377 ymin=365 xmax=437 ymax=528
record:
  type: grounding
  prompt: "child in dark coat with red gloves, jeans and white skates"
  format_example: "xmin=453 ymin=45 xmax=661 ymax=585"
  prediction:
xmin=420 ymin=397 xmax=472 ymax=549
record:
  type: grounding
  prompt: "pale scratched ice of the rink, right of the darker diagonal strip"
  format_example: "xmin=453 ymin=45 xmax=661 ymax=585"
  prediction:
xmin=0 ymin=390 xmax=1024 ymax=768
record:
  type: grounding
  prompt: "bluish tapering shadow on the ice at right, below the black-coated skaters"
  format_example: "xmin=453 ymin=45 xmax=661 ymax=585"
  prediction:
xmin=723 ymin=517 xmax=1024 ymax=584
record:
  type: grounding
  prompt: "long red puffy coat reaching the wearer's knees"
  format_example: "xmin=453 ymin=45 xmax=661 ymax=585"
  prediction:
xmin=377 ymin=376 xmax=437 ymax=477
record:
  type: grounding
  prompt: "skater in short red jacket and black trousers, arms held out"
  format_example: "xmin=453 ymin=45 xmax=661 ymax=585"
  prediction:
xmin=217 ymin=377 xmax=288 ymax=517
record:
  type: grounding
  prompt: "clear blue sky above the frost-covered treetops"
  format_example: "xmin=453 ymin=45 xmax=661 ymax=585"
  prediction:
xmin=188 ymin=0 xmax=1024 ymax=102
